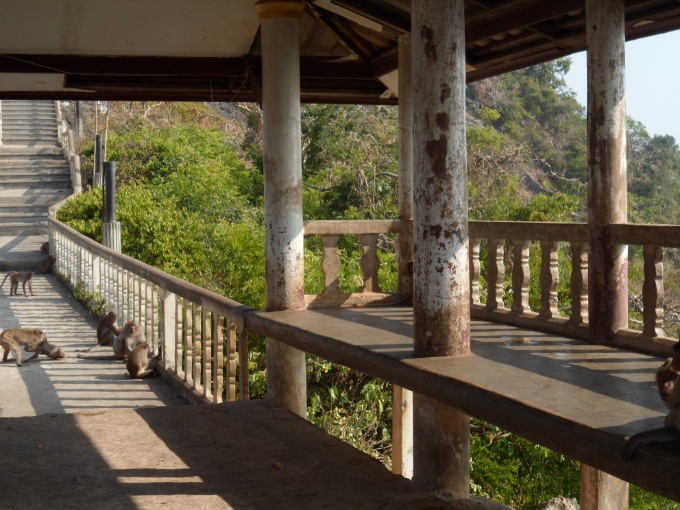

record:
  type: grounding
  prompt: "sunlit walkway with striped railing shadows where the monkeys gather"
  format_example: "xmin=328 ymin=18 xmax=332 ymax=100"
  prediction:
xmin=0 ymin=273 xmax=184 ymax=417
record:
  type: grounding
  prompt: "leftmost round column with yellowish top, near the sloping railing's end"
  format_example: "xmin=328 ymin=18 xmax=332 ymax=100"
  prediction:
xmin=255 ymin=0 xmax=307 ymax=417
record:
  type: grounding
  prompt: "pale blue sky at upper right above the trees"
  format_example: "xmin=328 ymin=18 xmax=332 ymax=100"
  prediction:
xmin=565 ymin=30 xmax=680 ymax=145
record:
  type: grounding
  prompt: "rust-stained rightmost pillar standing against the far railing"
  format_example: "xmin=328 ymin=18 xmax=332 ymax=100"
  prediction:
xmin=586 ymin=0 xmax=628 ymax=343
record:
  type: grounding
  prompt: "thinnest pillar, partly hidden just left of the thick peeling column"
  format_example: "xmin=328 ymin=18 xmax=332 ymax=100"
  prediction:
xmin=392 ymin=34 xmax=413 ymax=478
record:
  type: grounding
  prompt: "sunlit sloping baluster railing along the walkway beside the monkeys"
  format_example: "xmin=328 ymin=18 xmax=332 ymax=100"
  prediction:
xmin=49 ymin=218 xmax=250 ymax=403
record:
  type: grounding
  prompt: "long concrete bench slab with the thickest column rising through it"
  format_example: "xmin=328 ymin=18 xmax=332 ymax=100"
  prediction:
xmin=245 ymin=307 xmax=680 ymax=500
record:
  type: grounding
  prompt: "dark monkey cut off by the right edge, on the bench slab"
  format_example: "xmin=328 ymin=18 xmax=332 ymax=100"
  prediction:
xmin=621 ymin=342 xmax=680 ymax=460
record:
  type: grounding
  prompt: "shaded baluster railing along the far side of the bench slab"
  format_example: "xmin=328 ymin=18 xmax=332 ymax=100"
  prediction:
xmin=305 ymin=220 xmax=680 ymax=355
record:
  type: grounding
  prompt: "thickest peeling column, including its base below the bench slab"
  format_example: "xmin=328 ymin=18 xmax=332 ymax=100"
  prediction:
xmin=411 ymin=0 xmax=470 ymax=498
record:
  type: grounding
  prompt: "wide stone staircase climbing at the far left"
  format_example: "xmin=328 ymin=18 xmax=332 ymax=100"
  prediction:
xmin=0 ymin=100 xmax=71 ymax=237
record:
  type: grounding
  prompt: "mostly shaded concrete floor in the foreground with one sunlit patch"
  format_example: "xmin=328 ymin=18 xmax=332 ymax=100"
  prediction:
xmin=0 ymin=401 xmax=508 ymax=510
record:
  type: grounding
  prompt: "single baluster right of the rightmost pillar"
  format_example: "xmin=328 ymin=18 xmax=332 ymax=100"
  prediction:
xmin=642 ymin=246 xmax=664 ymax=337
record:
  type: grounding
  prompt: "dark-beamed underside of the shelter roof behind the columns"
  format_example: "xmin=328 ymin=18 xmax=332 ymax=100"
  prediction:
xmin=0 ymin=0 xmax=680 ymax=104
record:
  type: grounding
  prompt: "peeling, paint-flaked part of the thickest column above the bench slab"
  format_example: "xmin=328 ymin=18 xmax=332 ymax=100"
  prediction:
xmin=412 ymin=1 xmax=470 ymax=356
